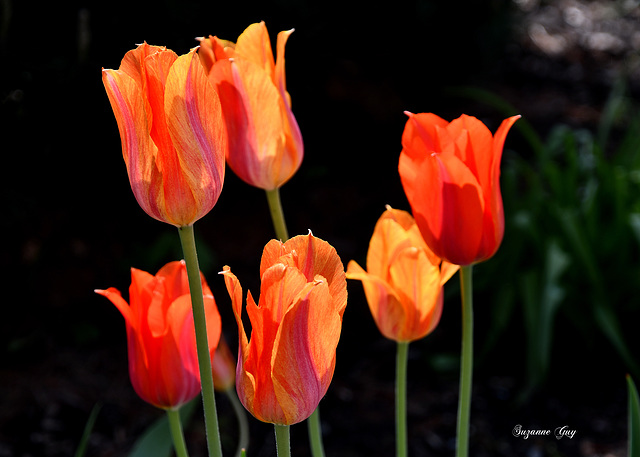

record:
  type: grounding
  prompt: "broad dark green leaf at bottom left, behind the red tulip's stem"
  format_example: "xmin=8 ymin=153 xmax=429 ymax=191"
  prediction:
xmin=129 ymin=395 xmax=201 ymax=457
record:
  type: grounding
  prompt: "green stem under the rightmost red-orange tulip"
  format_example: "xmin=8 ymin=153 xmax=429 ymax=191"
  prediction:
xmin=456 ymin=265 xmax=473 ymax=457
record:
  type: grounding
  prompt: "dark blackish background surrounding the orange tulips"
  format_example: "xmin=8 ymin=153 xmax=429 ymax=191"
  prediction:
xmin=0 ymin=0 xmax=639 ymax=457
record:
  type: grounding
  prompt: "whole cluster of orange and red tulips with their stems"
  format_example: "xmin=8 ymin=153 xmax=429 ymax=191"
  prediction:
xmin=96 ymin=23 xmax=517 ymax=457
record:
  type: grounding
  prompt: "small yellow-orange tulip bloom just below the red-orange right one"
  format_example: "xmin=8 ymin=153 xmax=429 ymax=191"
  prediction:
xmin=347 ymin=207 xmax=459 ymax=342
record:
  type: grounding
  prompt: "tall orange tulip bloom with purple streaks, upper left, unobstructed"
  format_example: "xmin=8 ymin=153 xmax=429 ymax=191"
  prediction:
xmin=102 ymin=43 xmax=227 ymax=227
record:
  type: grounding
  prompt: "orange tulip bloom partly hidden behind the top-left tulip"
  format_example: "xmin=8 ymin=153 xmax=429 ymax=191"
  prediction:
xmin=198 ymin=22 xmax=304 ymax=190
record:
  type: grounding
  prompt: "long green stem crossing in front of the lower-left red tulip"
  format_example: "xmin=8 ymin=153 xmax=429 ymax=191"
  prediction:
xmin=178 ymin=225 xmax=222 ymax=457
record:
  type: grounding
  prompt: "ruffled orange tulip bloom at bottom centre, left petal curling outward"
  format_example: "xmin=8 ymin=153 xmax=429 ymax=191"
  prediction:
xmin=222 ymin=233 xmax=347 ymax=425
